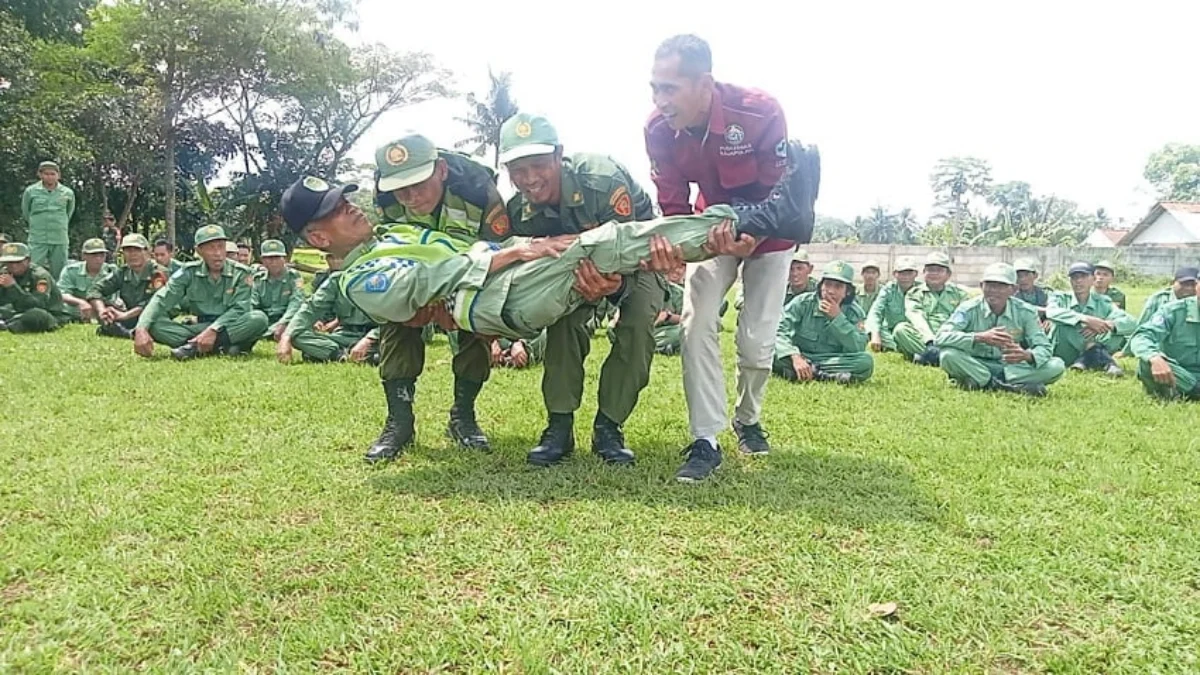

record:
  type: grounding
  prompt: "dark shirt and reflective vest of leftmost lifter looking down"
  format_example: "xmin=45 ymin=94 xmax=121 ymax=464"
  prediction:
xmin=376 ymin=149 xmax=511 ymax=244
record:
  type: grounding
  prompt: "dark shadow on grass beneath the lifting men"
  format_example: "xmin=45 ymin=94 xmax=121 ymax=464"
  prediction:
xmin=366 ymin=429 xmax=941 ymax=526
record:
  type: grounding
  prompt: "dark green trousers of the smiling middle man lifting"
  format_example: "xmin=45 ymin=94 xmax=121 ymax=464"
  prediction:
xmin=541 ymin=266 xmax=666 ymax=424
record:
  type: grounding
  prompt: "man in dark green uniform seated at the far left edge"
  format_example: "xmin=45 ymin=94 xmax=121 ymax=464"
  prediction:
xmin=0 ymin=244 xmax=68 ymax=333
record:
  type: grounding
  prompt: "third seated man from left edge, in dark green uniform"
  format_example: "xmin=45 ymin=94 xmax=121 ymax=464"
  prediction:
xmin=88 ymin=234 xmax=170 ymax=340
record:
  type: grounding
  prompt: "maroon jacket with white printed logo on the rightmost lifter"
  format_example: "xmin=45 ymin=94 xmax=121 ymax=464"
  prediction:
xmin=646 ymin=83 xmax=796 ymax=253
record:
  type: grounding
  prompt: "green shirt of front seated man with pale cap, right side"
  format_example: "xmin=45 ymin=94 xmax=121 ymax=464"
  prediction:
xmin=934 ymin=298 xmax=1054 ymax=368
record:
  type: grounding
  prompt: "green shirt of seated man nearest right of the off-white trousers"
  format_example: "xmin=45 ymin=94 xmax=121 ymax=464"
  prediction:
xmin=775 ymin=293 xmax=866 ymax=359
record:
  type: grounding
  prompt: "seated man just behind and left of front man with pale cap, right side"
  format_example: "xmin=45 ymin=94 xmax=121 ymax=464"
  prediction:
xmin=893 ymin=251 xmax=968 ymax=366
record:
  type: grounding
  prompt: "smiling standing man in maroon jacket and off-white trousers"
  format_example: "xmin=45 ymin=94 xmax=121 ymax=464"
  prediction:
xmin=646 ymin=35 xmax=817 ymax=482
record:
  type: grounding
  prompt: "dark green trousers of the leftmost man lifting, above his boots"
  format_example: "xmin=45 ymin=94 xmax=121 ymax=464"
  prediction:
xmin=379 ymin=323 xmax=492 ymax=383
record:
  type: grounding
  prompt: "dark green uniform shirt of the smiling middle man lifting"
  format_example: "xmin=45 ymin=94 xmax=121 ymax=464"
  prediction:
xmin=509 ymin=153 xmax=654 ymax=237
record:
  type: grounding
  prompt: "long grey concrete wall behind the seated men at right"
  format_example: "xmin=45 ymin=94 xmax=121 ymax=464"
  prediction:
xmin=804 ymin=244 xmax=1200 ymax=286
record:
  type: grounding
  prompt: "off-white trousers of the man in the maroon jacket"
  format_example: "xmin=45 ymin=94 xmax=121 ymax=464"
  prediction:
xmin=680 ymin=249 xmax=792 ymax=438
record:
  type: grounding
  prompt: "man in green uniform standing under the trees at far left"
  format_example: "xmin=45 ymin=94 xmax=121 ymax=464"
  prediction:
xmin=20 ymin=162 xmax=74 ymax=279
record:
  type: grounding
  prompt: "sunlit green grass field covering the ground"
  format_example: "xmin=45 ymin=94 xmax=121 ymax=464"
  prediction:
xmin=0 ymin=283 xmax=1200 ymax=674
